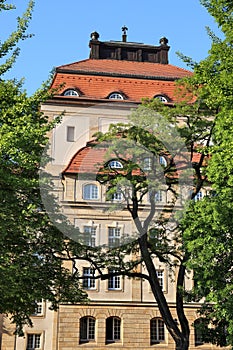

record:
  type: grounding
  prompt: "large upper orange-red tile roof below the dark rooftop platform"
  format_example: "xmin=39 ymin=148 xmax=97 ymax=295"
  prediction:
xmin=52 ymin=59 xmax=192 ymax=102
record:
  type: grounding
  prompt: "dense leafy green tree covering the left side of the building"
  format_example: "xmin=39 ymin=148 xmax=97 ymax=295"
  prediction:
xmin=0 ymin=1 xmax=86 ymax=333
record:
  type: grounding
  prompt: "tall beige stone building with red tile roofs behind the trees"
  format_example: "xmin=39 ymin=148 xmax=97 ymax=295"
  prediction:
xmin=2 ymin=27 xmax=225 ymax=350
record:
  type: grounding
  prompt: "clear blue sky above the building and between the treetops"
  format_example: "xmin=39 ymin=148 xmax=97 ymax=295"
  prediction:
xmin=0 ymin=0 xmax=221 ymax=95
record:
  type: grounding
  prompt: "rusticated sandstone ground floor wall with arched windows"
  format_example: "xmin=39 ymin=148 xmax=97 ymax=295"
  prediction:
xmin=0 ymin=302 xmax=228 ymax=350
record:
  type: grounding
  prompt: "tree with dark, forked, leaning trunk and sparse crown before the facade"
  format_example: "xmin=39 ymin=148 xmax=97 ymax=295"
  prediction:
xmin=80 ymin=95 xmax=213 ymax=350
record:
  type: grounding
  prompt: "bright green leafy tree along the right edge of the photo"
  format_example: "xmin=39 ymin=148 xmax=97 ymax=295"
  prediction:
xmin=180 ymin=0 xmax=233 ymax=345
